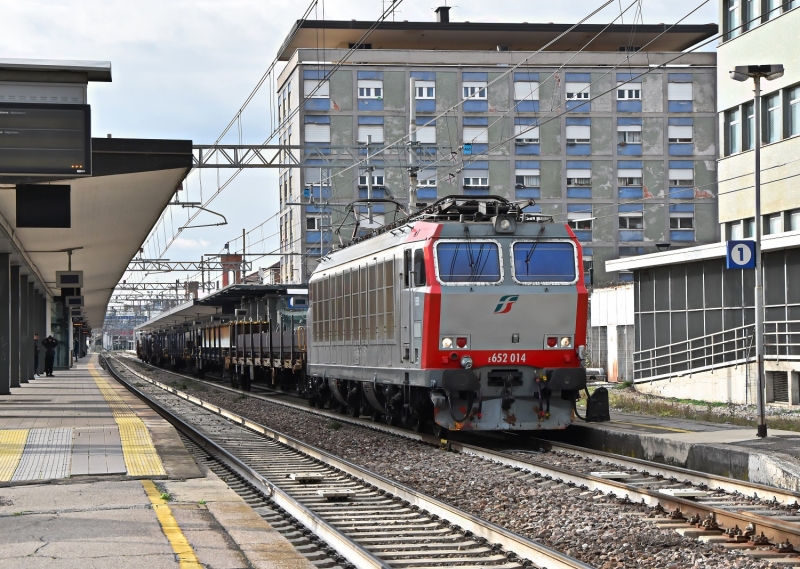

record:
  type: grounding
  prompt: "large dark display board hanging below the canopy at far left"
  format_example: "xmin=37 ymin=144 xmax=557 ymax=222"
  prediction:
xmin=0 ymin=103 xmax=92 ymax=177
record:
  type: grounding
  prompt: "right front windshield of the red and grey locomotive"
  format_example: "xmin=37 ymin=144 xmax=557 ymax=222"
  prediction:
xmin=511 ymin=241 xmax=577 ymax=284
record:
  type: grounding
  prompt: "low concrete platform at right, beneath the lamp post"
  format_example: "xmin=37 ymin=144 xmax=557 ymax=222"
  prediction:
xmin=543 ymin=412 xmax=800 ymax=491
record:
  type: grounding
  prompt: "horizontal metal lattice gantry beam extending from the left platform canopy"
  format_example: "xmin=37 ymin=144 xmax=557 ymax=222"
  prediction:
xmin=192 ymin=144 xmax=446 ymax=169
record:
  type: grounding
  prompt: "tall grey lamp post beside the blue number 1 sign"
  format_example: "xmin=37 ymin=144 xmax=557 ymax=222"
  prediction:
xmin=730 ymin=65 xmax=783 ymax=438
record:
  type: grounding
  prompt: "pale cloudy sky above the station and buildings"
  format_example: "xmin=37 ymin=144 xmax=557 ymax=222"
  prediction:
xmin=2 ymin=0 xmax=718 ymax=288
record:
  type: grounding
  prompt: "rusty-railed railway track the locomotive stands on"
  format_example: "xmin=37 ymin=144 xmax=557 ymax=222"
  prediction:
xmin=114 ymin=358 xmax=800 ymax=567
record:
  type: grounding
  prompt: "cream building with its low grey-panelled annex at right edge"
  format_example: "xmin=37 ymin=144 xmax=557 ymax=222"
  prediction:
xmin=607 ymin=0 xmax=800 ymax=405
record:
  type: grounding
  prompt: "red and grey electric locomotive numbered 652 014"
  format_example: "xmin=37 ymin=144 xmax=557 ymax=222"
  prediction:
xmin=304 ymin=196 xmax=607 ymax=434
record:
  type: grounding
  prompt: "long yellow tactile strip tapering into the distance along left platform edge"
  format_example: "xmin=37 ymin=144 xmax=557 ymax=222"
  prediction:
xmin=87 ymin=364 xmax=167 ymax=476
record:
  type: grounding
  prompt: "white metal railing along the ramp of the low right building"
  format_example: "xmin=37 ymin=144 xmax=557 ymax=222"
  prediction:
xmin=633 ymin=320 xmax=800 ymax=381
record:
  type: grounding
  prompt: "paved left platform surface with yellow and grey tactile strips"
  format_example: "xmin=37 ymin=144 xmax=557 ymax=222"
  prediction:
xmin=0 ymin=352 xmax=313 ymax=569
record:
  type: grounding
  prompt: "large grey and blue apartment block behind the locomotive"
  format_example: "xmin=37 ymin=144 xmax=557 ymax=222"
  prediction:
xmin=277 ymin=14 xmax=719 ymax=284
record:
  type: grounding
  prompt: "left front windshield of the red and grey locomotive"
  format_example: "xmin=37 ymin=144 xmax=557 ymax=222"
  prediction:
xmin=436 ymin=241 xmax=501 ymax=283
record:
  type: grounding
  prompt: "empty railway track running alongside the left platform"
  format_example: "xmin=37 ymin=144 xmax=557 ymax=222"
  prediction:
xmin=106 ymin=360 xmax=590 ymax=569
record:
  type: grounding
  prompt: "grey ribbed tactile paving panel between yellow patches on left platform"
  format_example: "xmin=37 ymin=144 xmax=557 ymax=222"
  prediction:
xmin=11 ymin=427 xmax=72 ymax=481
